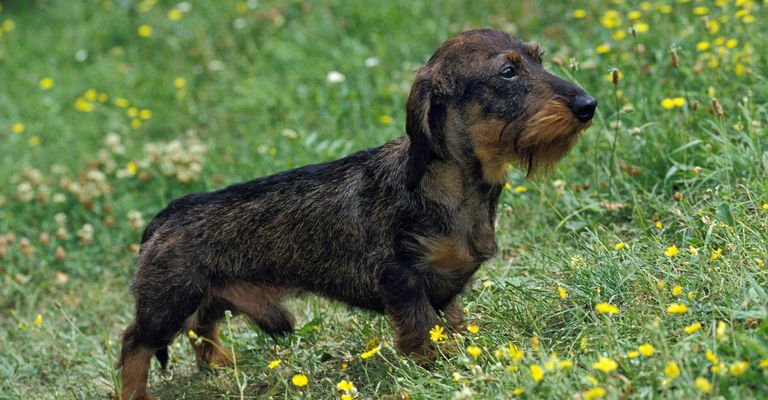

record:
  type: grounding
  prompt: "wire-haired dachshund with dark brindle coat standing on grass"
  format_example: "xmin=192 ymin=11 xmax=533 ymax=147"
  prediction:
xmin=118 ymin=29 xmax=597 ymax=400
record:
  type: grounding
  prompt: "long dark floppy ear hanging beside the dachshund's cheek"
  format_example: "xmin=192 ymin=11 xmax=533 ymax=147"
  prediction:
xmin=405 ymin=65 xmax=452 ymax=191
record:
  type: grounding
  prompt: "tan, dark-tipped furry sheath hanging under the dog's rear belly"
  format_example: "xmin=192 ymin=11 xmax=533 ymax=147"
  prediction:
xmin=211 ymin=282 xmax=294 ymax=335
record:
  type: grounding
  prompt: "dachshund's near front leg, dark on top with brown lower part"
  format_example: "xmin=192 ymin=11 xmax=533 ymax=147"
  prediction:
xmin=379 ymin=265 xmax=440 ymax=356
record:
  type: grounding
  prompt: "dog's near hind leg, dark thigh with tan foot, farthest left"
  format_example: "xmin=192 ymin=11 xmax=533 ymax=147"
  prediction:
xmin=118 ymin=265 xmax=205 ymax=400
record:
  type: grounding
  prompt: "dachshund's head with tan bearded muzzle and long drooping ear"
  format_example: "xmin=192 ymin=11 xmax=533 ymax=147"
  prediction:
xmin=406 ymin=29 xmax=597 ymax=190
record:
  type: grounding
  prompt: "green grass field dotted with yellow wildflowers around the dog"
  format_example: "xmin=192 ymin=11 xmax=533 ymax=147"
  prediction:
xmin=0 ymin=0 xmax=768 ymax=399
